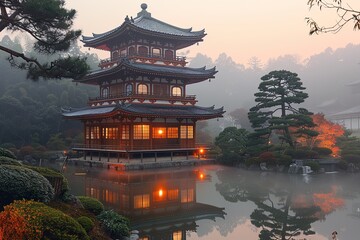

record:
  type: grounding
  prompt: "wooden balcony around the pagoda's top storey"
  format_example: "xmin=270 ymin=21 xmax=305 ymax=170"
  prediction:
xmin=99 ymin=54 xmax=187 ymax=69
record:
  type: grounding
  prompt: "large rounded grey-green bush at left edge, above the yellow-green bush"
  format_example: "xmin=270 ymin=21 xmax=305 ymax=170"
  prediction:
xmin=0 ymin=165 xmax=54 ymax=207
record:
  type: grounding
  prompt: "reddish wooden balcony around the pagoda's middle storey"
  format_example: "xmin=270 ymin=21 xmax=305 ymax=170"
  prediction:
xmin=88 ymin=93 xmax=197 ymax=106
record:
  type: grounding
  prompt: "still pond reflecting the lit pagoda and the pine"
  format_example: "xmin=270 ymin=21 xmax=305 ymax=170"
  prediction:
xmin=59 ymin=165 xmax=360 ymax=240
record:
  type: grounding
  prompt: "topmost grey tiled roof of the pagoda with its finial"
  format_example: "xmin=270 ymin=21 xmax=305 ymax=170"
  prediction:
xmin=82 ymin=3 xmax=206 ymax=46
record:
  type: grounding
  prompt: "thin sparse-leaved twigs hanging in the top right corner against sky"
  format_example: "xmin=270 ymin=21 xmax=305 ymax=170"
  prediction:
xmin=306 ymin=0 xmax=360 ymax=35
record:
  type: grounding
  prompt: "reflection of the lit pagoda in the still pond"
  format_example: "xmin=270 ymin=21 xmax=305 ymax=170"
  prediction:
xmin=85 ymin=170 xmax=225 ymax=240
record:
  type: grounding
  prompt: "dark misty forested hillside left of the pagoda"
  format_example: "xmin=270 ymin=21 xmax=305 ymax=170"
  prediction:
xmin=0 ymin=36 xmax=98 ymax=150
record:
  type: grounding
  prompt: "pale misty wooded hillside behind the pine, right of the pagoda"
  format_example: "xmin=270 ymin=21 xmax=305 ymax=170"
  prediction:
xmin=188 ymin=44 xmax=360 ymax=118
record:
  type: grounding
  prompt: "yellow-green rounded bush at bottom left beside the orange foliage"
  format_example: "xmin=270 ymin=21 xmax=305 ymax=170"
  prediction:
xmin=11 ymin=201 xmax=89 ymax=240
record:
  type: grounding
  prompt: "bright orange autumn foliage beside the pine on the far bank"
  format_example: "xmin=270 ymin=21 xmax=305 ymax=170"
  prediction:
xmin=298 ymin=113 xmax=345 ymax=156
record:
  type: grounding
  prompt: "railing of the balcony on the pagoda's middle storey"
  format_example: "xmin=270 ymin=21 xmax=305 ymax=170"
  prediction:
xmin=89 ymin=93 xmax=196 ymax=104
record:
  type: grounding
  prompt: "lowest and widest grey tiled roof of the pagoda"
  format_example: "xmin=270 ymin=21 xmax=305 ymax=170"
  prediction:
xmin=62 ymin=103 xmax=225 ymax=119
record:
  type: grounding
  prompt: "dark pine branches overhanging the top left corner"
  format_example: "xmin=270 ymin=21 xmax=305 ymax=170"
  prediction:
xmin=0 ymin=0 xmax=89 ymax=80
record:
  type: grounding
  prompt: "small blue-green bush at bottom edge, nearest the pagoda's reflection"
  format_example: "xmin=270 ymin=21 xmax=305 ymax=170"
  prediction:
xmin=97 ymin=210 xmax=130 ymax=239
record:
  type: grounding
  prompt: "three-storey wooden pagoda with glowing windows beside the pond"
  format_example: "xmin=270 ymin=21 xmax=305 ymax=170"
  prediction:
xmin=63 ymin=4 xmax=224 ymax=160
